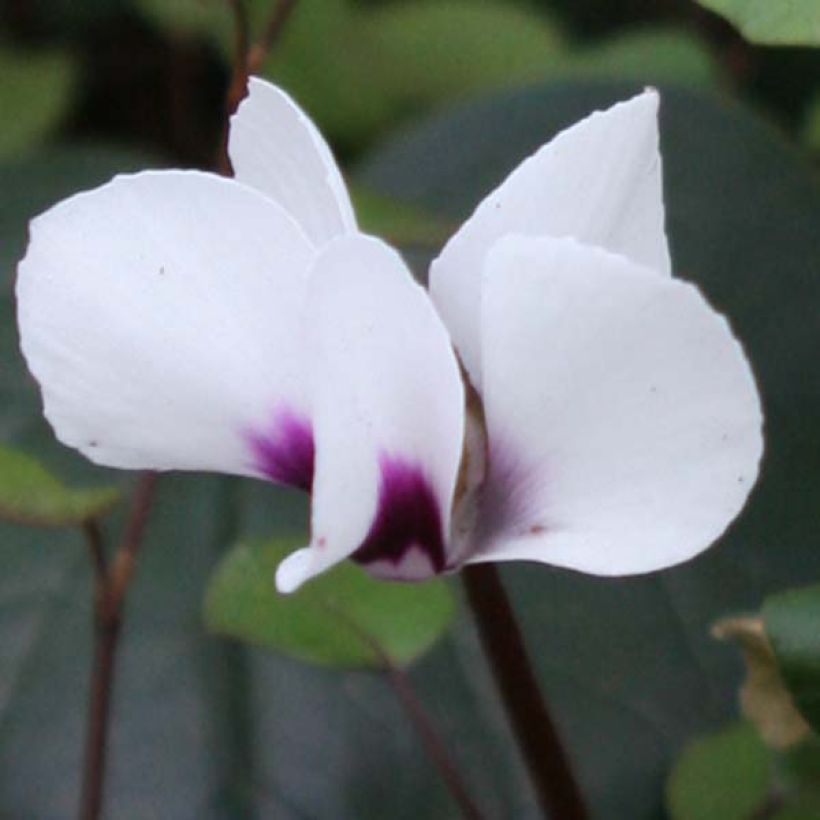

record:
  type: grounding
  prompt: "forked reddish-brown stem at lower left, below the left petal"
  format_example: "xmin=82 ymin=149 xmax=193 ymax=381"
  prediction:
xmin=79 ymin=473 xmax=161 ymax=820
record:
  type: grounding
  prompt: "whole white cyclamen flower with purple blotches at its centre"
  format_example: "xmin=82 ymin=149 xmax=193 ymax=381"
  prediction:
xmin=17 ymin=79 xmax=762 ymax=591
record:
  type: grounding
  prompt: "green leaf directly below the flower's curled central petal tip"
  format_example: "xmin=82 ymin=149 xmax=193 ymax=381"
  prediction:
xmin=205 ymin=536 xmax=455 ymax=667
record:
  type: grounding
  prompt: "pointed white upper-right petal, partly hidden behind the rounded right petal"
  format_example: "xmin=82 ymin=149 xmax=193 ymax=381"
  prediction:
xmin=430 ymin=90 xmax=671 ymax=389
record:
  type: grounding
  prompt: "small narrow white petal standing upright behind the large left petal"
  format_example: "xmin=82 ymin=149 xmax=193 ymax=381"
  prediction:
xmin=228 ymin=77 xmax=356 ymax=245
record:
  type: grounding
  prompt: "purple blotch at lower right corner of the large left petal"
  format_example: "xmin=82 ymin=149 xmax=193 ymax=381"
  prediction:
xmin=247 ymin=409 xmax=315 ymax=492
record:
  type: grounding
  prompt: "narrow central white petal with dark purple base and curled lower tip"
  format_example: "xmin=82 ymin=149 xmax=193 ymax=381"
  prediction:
xmin=276 ymin=236 xmax=464 ymax=592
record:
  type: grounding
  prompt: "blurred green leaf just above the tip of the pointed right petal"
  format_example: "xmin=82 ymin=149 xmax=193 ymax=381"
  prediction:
xmin=553 ymin=27 xmax=720 ymax=86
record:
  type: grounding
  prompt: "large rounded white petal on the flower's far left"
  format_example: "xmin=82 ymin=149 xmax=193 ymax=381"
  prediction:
xmin=17 ymin=171 xmax=314 ymax=485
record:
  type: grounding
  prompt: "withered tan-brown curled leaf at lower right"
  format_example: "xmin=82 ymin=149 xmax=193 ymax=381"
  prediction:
xmin=712 ymin=617 xmax=811 ymax=749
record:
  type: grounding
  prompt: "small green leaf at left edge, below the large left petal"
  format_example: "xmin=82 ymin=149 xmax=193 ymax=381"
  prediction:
xmin=0 ymin=445 xmax=120 ymax=527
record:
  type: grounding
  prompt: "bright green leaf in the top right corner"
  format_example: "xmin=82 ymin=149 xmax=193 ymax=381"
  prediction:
xmin=698 ymin=0 xmax=820 ymax=46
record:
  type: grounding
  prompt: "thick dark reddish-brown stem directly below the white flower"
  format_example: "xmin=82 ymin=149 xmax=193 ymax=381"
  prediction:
xmin=462 ymin=564 xmax=588 ymax=820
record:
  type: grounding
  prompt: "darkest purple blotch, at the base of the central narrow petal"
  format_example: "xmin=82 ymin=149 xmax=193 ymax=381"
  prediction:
xmin=351 ymin=455 xmax=446 ymax=577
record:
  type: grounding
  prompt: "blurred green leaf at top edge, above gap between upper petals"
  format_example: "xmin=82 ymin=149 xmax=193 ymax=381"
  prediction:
xmin=367 ymin=0 xmax=564 ymax=105
